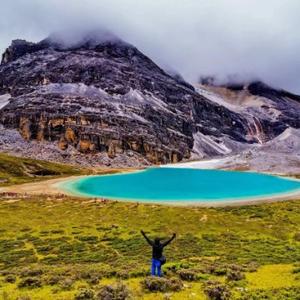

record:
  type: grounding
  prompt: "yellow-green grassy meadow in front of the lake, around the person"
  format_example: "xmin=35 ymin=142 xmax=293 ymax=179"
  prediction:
xmin=0 ymin=197 xmax=300 ymax=299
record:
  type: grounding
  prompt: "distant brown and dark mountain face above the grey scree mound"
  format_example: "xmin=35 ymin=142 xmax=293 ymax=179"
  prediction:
xmin=196 ymin=81 xmax=300 ymax=148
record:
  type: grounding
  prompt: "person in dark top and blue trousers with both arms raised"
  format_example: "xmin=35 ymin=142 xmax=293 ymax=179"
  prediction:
xmin=141 ymin=230 xmax=176 ymax=277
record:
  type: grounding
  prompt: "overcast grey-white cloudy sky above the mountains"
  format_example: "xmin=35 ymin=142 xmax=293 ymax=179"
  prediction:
xmin=0 ymin=0 xmax=300 ymax=93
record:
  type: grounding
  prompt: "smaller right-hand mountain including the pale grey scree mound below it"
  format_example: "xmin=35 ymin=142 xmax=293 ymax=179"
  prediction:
xmin=196 ymin=81 xmax=300 ymax=174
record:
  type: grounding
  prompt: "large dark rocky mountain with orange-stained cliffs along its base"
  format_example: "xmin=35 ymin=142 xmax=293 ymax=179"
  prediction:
xmin=0 ymin=34 xmax=248 ymax=163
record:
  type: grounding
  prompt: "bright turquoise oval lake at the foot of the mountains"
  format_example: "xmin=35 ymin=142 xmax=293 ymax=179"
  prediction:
xmin=62 ymin=168 xmax=300 ymax=203
